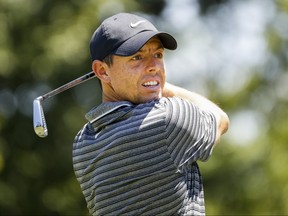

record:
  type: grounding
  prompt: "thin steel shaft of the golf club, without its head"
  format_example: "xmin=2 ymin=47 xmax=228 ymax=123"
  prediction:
xmin=37 ymin=71 xmax=95 ymax=101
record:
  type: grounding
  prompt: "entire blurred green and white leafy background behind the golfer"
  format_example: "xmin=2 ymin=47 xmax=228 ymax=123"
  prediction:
xmin=0 ymin=0 xmax=288 ymax=215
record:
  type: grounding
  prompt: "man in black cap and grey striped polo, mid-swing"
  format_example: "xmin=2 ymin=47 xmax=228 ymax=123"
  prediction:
xmin=73 ymin=13 xmax=229 ymax=215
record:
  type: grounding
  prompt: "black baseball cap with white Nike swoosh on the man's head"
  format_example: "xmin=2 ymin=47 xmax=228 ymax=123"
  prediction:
xmin=90 ymin=13 xmax=177 ymax=61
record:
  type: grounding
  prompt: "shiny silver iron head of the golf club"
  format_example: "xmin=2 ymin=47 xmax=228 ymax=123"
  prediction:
xmin=33 ymin=97 xmax=48 ymax=137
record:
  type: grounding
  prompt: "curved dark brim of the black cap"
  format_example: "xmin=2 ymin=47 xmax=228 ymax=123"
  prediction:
xmin=112 ymin=31 xmax=177 ymax=56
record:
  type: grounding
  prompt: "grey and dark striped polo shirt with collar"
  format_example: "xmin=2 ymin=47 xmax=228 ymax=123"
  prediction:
xmin=73 ymin=97 xmax=216 ymax=215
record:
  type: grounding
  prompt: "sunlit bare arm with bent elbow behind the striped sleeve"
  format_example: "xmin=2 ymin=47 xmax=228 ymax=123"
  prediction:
xmin=163 ymin=83 xmax=229 ymax=142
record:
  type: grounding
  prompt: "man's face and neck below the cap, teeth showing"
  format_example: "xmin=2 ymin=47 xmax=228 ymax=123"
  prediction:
xmin=109 ymin=37 xmax=165 ymax=104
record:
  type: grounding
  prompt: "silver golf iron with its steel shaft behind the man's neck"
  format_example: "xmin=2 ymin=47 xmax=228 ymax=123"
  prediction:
xmin=33 ymin=71 xmax=95 ymax=137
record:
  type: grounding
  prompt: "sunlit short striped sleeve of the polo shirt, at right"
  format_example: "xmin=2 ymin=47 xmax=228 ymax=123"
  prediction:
xmin=166 ymin=97 xmax=217 ymax=170
